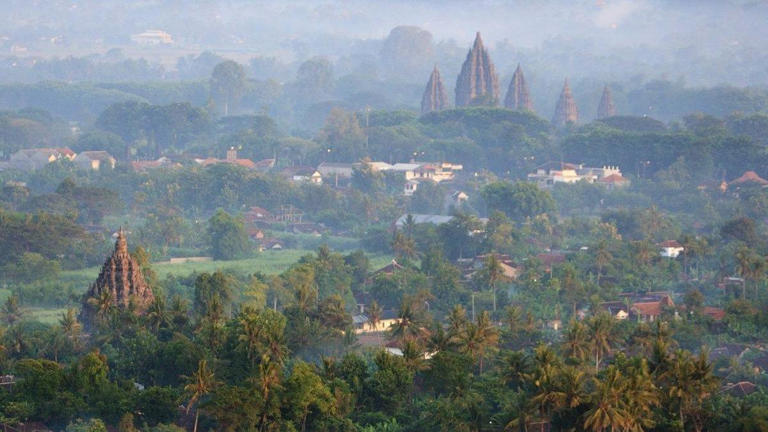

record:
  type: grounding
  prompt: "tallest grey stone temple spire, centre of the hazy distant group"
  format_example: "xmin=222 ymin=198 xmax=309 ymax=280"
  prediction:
xmin=456 ymin=32 xmax=499 ymax=107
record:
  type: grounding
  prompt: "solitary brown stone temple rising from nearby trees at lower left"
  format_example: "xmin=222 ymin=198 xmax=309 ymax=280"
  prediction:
xmin=82 ymin=228 xmax=155 ymax=323
